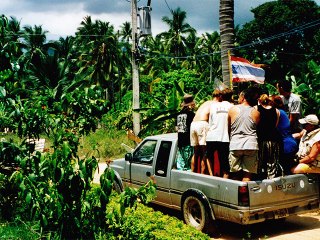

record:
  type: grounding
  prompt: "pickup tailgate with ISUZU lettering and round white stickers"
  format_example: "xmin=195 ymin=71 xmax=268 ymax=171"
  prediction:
xmin=248 ymin=174 xmax=319 ymax=209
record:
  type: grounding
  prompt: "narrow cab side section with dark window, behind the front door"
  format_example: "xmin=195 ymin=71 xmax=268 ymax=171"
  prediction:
xmin=154 ymin=141 xmax=172 ymax=205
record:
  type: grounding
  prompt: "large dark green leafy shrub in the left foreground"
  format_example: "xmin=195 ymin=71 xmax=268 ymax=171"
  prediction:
xmin=0 ymin=79 xmax=162 ymax=239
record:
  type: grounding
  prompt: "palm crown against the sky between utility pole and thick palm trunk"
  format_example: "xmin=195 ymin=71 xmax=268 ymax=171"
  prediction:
xmin=161 ymin=7 xmax=196 ymax=63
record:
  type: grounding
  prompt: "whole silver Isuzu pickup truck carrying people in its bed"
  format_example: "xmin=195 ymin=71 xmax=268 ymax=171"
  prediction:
xmin=110 ymin=133 xmax=319 ymax=231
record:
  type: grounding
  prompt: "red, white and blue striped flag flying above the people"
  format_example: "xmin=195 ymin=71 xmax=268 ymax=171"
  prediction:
xmin=231 ymin=56 xmax=265 ymax=84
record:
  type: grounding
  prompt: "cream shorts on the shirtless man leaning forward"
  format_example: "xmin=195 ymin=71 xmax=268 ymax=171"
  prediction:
xmin=190 ymin=121 xmax=209 ymax=146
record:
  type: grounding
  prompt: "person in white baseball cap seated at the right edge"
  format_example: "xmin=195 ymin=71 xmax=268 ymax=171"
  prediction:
xmin=292 ymin=114 xmax=320 ymax=173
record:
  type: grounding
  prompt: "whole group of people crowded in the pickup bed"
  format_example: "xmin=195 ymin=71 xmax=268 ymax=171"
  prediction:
xmin=176 ymin=81 xmax=320 ymax=181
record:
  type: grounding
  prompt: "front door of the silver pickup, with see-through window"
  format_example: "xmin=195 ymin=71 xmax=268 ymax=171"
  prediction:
xmin=129 ymin=140 xmax=157 ymax=187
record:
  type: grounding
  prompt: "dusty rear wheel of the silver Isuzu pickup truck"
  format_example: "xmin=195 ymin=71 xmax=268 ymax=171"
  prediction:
xmin=182 ymin=195 xmax=210 ymax=232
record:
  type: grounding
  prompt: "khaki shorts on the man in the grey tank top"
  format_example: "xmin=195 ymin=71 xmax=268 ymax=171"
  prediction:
xmin=229 ymin=150 xmax=258 ymax=173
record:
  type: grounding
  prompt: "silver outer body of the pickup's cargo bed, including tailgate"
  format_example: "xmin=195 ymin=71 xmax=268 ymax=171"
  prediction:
xmin=170 ymin=170 xmax=319 ymax=224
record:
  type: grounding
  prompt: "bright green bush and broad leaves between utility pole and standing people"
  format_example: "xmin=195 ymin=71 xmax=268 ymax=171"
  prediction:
xmin=140 ymin=69 xmax=212 ymax=136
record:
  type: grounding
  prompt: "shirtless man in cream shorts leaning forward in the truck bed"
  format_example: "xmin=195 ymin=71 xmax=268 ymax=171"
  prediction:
xmin=190 ymin=90 xmax=220 ymax=175
